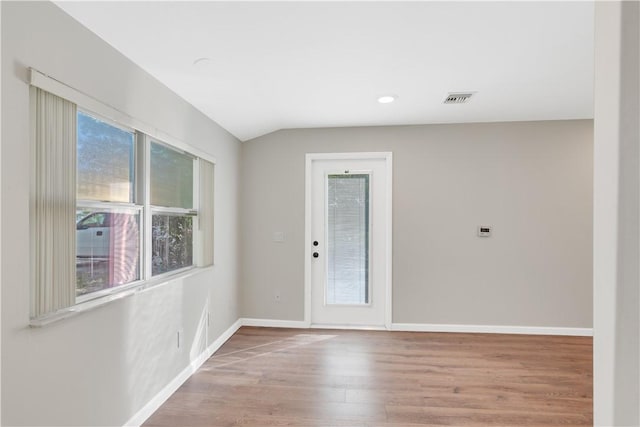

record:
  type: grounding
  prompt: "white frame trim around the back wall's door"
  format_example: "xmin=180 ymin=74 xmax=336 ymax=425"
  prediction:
xmin=304 ymin=151 xmax=393 ymax=330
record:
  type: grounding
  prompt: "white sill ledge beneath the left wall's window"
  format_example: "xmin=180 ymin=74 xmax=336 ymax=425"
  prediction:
xmin=29 ymin=266 xmax=213 ymax=328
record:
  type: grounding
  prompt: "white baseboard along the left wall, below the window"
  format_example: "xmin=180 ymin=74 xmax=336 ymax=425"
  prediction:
xmin=124 ymin=319 xmax=242 ymax=427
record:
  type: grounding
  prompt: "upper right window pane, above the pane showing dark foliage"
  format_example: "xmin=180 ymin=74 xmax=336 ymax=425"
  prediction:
xmin=150 ymin=143 xmax=193 ymax=209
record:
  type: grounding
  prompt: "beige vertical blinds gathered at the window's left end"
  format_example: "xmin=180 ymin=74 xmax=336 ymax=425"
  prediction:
xmin=32 ymin=88 xmax=77 ymax=316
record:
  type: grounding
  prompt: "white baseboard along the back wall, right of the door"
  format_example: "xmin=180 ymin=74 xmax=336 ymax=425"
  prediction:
xmin=391 ymin=323 xmax=593 ymax=337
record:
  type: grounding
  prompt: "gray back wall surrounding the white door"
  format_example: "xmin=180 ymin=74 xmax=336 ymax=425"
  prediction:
xmin=241 ymin=121 xmax=593 ymax=328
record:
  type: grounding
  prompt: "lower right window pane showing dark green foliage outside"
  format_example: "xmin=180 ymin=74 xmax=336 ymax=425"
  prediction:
xmin=151 ymin=214 xmax=193 ymax=276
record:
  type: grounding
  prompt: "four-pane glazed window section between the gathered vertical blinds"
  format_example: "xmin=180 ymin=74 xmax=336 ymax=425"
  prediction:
xmin=76 ymin=116 xmax=197 ymax=297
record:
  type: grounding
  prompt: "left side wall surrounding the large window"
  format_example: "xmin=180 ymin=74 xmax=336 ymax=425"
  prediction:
xmin=0 ymin=2 xmax=240 ymax=426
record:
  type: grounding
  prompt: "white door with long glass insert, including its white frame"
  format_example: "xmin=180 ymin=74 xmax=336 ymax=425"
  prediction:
xmin=306 ymin=153 xmax=391 ymax=327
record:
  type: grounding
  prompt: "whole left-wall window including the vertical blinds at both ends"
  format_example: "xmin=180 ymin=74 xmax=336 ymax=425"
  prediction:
xmin=31 ymin=80 xmax=214 ymax=318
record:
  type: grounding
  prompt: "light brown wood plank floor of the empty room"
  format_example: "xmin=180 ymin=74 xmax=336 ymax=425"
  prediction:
xmin=144 ymin=327 xmax=593 ymax=427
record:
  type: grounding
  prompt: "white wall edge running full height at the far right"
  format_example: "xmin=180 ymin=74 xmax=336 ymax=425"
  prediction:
xmin=593 ymin=1 xmax=640 ymax=426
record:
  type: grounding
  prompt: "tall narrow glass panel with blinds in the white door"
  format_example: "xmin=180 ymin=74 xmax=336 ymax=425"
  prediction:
xmin=325 ymin=174 xmax=369 ymax=304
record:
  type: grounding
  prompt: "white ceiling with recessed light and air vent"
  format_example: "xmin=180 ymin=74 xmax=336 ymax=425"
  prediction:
xmin=56 ymin=1 xmax=594 ymax=140
